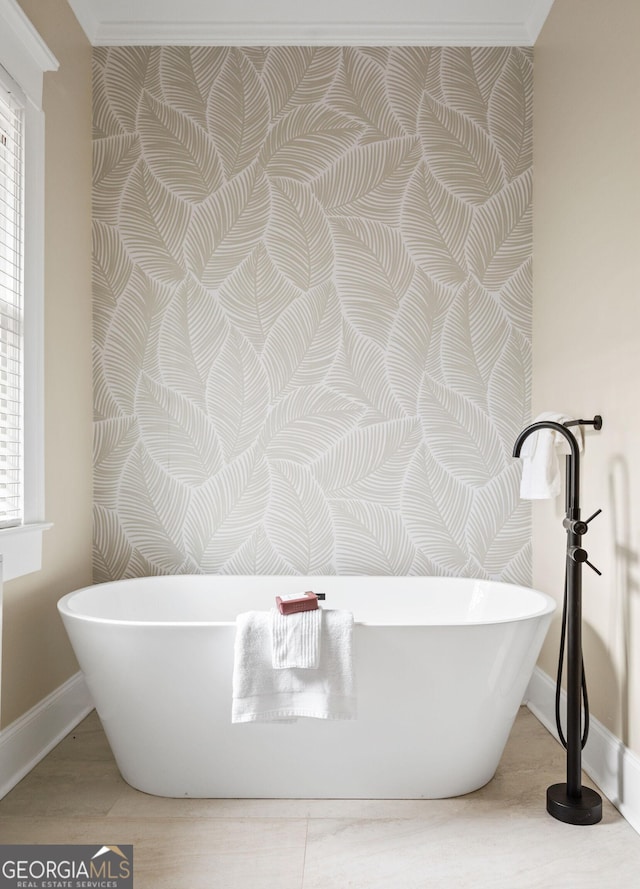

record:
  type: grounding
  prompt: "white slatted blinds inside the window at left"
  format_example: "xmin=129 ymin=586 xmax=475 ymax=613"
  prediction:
xmin=0 ymin=72 xmax=24 ymax=528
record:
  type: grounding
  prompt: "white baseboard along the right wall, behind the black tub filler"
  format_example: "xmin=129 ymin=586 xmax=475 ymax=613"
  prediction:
xmin=525 ymin=667 xmax=640 ymax=833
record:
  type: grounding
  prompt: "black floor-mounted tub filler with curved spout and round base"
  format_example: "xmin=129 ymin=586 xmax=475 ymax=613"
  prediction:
xmin=513 ymin=414 xmax=602 ymax=824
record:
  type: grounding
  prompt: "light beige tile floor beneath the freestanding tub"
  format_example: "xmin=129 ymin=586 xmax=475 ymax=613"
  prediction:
xmin=0 ymin=708 xmax=640 ymax=889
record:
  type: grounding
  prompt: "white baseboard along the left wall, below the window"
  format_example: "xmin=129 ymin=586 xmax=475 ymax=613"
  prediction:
xmin=0 ymin=673 xmax=93 ymax=799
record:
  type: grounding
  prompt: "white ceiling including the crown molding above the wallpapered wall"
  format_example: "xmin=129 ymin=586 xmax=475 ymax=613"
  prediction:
xmin=69 ymin=0 xmax=553 ymax=46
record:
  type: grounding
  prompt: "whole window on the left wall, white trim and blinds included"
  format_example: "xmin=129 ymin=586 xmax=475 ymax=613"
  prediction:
xmin=0 ymin=0 xmax=58 ymax=580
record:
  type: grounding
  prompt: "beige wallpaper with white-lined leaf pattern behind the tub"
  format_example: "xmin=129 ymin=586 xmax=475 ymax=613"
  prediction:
xmin=94 ymin=47 xmax=532 ymax=582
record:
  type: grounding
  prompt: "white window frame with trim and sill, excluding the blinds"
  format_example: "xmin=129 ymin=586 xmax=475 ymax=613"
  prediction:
xmin=0 ymin=0 xmax=58 ymax=580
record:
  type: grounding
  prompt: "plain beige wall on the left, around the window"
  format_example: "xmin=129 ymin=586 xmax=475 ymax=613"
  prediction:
xmin=2 ymin=0 xmax=92 ymax=726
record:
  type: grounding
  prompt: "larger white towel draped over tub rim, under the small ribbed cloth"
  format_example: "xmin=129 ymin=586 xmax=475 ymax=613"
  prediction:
xmin=231 ymin=609 xmax=356 ymax=722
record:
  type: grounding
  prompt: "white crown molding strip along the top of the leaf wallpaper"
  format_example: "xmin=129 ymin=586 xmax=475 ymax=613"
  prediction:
xmin=91 ymin=20 xmax=536 ymax=46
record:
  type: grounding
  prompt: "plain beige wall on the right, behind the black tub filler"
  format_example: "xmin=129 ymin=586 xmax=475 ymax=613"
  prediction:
xmin=533 ymin=0 xmax=640 ymax=753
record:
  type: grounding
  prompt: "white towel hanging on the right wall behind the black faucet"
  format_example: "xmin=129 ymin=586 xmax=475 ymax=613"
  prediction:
xmin=520 ymin=411 xmax=584 ymax=500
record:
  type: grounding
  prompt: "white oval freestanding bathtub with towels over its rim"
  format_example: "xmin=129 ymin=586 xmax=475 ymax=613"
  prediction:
xmin=58 ymin=575 xmax=555 ymax=799
